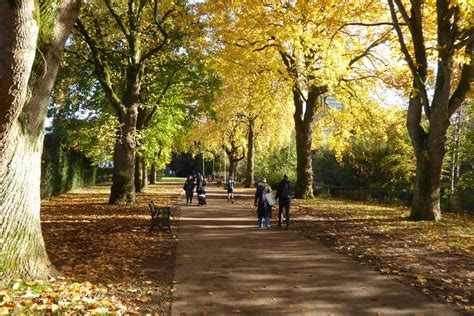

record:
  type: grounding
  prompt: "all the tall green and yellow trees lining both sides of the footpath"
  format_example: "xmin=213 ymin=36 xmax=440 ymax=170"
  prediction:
xmin=0 ymin=0 xmax=474 ymax=281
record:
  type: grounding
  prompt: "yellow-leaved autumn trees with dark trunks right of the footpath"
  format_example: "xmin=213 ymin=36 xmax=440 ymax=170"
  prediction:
xmin=192 ymin=0 xmax=474 ymax=220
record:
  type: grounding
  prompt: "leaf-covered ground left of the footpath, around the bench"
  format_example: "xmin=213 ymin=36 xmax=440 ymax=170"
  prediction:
xmin=0 ymin=185 xmax=180 ymax=315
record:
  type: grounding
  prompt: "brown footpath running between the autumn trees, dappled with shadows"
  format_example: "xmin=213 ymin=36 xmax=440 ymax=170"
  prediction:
xmin=171 ymin=187 xmax=456 ymax=316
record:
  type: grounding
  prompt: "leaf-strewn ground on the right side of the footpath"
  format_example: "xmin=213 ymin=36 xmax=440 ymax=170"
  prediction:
xmin=293 ymin=198 xmax=474 ymax=314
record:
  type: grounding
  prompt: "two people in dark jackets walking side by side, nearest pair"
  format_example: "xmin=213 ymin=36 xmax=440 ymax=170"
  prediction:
xmin=254 ymin=175 xmax=293 ymax=229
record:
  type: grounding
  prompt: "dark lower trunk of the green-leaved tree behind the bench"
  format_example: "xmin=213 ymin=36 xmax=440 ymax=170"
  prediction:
xmin=109 ymin=105 xmax=138 ymax=204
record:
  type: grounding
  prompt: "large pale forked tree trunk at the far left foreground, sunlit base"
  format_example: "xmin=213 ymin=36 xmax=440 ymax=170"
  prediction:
xmin=0 ymin=0 xmax=79 ymax=284
